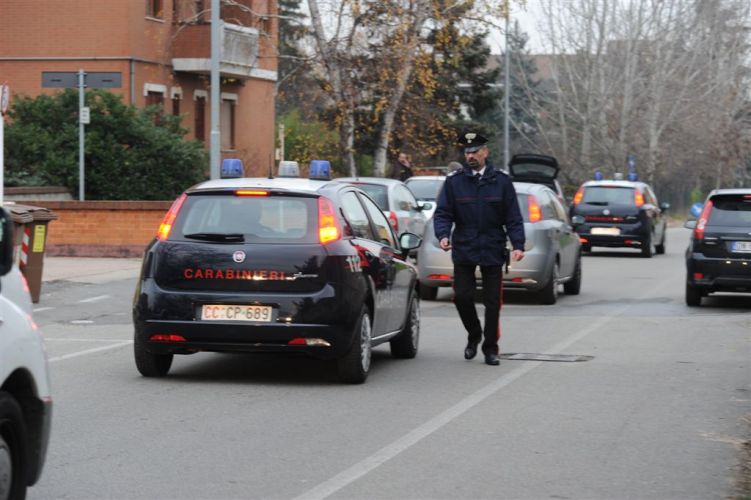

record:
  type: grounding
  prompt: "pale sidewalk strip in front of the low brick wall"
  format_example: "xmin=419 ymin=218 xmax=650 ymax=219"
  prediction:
xmin=42 ymin=257 xmax=141 ymax=283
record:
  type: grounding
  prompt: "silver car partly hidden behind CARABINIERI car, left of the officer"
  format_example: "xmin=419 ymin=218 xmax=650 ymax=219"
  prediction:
xmin=338 ymin=177 xmax=432 ymax=237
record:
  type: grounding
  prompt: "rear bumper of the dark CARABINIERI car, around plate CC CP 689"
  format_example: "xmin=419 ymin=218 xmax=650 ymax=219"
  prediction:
xmin=133 ymin=280 xmax=365 ymax=358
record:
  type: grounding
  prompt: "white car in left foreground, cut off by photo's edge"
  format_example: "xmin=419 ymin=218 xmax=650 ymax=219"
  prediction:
xmin=0 ymin=208 xmax=52 ymax=500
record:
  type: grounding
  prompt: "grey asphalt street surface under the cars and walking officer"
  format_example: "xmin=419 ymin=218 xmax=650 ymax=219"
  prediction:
xmin=28 ymin=228 xmax=751 ymax=500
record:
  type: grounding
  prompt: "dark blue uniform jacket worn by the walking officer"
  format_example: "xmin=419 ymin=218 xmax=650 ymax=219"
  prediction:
xmin=433 ymin=162 xmax=524 ymax=266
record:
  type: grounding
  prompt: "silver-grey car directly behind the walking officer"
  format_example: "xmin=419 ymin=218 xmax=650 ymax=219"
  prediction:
xmin=417 ymin=182 xmax=582 ymax=304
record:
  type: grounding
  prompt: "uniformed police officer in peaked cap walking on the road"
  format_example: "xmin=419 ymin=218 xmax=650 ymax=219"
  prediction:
xmin=433 ymin=132 xmax=524 ymax=365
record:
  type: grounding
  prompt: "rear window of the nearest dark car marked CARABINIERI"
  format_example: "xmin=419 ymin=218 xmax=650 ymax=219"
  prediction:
xmin=173 ymin=194 xmax=318 ymax=243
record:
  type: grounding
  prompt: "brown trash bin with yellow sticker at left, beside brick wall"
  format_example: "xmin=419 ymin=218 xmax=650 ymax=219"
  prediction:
xmin=5 ymin=203 xmax=57 ymax=304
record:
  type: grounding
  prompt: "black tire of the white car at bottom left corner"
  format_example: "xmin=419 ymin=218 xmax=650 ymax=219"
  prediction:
xmin=0 ymin=391 xmax=29 ymax=499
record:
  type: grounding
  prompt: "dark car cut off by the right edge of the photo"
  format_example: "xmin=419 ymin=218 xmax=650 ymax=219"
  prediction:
xmin=685 ymin=189 xmax=751 ymax=306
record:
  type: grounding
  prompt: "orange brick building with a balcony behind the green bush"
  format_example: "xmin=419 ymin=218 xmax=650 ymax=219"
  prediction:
xmin=0 ymin=0 xmax=278 ymax=175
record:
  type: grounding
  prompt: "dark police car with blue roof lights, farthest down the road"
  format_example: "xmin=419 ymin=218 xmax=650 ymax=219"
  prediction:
xmin=571 ymin=180 xmax=670 ymax=257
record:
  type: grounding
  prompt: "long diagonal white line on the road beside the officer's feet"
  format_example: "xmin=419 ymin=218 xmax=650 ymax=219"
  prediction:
xmin=295 ymin=280 xmax=670 ymax=500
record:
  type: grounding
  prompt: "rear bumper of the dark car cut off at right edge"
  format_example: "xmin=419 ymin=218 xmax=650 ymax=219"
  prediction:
xmin=686 ymin=253 xmax=751 ymax=293
